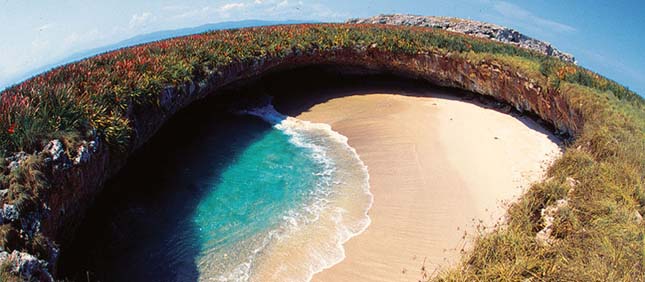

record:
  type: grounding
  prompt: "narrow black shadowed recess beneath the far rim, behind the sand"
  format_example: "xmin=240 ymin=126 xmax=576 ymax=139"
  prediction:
xmin=264 ymin=67 xmax=568 ymax=144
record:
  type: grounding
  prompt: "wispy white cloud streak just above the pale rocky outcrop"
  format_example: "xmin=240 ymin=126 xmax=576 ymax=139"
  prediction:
xmin=493 ymin=1 xmax=576 ymax=33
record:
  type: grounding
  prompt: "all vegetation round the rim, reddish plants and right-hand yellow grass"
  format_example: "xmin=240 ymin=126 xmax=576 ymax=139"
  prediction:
xmin=0 ymin=25 xmax=645 ymax=281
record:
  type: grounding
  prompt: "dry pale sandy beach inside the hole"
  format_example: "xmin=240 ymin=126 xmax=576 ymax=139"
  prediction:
xmin=282 ymin=89 xmax=560 ymax=281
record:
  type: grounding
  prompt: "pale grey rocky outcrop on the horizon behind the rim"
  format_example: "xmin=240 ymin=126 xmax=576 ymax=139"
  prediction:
xmin=347 ymin=15 xmax=576 ymax=63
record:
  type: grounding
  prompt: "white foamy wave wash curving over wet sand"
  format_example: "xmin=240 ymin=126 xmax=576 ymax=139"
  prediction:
xmin=199 ymin=104 xmax=373 ymax=281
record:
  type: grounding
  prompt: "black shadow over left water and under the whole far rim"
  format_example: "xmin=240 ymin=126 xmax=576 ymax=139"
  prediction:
xmin=59 ymin=65 xmax=560 ymax=281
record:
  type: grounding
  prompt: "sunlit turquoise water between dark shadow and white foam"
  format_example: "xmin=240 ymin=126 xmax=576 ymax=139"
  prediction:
xmin=193 ymin=129 xmax=330 ymax=280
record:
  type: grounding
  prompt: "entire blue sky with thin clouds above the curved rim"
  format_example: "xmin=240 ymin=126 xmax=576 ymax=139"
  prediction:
xmin=0 ymin=0 xmax=645 ymax=95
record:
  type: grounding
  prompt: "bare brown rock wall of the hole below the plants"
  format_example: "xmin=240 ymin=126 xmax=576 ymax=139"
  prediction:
xmin=0 ymin=46 xmax=583 ymax=278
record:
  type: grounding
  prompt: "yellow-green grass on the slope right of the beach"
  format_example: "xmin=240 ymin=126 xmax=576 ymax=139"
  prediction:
xmin=435 ymin=82 xmax=645 ymax=281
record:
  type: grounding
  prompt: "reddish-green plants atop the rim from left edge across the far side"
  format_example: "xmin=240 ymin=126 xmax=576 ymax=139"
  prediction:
xmin=0 ymin=25 xmax=640 ymax=152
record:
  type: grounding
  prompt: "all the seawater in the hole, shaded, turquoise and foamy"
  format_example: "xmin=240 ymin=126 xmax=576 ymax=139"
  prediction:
xmin=63 ymin=102 xmax=372 ymax=281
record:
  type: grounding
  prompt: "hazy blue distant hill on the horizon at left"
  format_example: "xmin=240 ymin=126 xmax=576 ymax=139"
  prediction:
xmin=0 ymin=20 xmax=315 ymax=90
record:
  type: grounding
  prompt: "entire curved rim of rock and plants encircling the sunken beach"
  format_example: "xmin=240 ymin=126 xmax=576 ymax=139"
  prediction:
xmin=0 ymin=20 xmax=645 ymax=281
